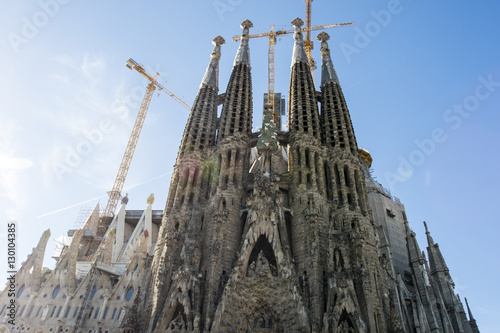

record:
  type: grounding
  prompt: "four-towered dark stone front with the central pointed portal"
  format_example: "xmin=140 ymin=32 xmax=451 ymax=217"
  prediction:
xmin=144 ymin=18 xmax=399 ymax=332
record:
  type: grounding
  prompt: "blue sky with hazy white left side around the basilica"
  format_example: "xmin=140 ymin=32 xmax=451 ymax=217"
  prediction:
xmin=0 ymin=0 xmax=500 ymax=332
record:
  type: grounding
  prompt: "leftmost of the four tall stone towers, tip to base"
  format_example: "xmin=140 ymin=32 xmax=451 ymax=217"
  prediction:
xmin=146 ymin=36 xmax=225 ymax=331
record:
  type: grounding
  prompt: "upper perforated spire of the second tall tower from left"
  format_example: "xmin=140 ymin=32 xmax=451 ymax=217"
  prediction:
xmin=217 ymin=20 xmax=253 ymax=144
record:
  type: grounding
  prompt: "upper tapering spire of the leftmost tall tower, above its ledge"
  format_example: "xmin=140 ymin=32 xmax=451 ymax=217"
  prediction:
xmin=179 ymin=36 xmax=225 ymax=157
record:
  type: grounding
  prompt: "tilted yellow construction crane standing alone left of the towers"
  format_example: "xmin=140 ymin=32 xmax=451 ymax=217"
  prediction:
xmin=97 ymin=58 xmax=191 ymax=237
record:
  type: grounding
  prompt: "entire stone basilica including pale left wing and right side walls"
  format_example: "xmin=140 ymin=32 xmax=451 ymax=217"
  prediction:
xmin=0 ymin=19 xmax=479 ymax=333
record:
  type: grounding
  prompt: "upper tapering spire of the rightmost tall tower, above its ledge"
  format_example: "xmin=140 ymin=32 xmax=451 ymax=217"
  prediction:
xmin=317 ymin=32 xmax=358 ymax=153
